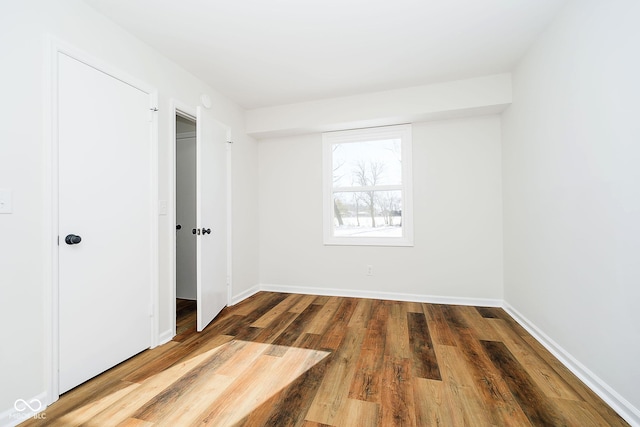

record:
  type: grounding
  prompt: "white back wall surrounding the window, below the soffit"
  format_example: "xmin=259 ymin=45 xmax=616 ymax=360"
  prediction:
xmin=259 ymin=116 xmax=502 ymax=301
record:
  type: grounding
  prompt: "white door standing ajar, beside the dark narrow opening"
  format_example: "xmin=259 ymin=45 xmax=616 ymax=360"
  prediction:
xmin=196 ymin=107 xmax=227 ymax=331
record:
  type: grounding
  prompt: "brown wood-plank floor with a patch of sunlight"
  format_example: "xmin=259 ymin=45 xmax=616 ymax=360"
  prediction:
xmin=23 ymin=292 xmax=628 ymax=427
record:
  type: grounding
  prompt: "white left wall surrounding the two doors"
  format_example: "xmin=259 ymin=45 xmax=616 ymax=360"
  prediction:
xmin=0 ymin=0 xmax=258 ymax=418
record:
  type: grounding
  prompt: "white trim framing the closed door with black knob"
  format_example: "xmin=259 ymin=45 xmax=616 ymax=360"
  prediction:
xmin=43 ymin=36 xmax=159 ymax=405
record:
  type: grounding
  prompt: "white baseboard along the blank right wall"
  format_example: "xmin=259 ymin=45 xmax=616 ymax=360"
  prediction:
xmin=503 ymin=301 xmax=640 ymax=427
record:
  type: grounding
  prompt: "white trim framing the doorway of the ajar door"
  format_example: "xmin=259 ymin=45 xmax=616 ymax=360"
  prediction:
xmin=168 ymin=98 xmax=232 ymax=344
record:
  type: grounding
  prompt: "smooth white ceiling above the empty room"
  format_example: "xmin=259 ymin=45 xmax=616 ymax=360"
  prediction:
xmin=85 ymin=0 xmax=565 ymax=109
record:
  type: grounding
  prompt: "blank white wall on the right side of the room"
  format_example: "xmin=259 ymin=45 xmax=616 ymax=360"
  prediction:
xmin=503 ymin=0 xmax=640 ymax=425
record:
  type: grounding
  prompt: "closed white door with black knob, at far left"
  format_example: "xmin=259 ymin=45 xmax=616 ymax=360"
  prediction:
xmin=57 ymin=53 xmax=155 ymax=393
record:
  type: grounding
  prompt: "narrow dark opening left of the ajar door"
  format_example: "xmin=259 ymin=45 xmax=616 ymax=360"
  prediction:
xmin=175 ymin=112 xmax=197 ymax=334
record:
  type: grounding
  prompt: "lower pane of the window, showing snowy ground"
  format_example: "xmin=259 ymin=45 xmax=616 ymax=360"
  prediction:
xmin=333 ymin=190 xmax=402 ymax=237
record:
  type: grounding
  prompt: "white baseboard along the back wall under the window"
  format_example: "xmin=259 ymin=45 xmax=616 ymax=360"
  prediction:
xmin=259 ymin=283 xmax=502 ymax=307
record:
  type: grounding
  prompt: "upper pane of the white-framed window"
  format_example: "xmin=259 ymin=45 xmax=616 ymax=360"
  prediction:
xmin=332 ymin=139 xmax=402 ymax=188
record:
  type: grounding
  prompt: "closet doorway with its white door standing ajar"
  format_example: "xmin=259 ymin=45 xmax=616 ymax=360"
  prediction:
xmin=171 ymin=104 xmax=231 ymax=333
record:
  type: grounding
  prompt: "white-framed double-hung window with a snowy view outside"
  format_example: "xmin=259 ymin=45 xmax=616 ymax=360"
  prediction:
xmin=323 ymin=125 xmax=413 ymax=246
